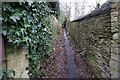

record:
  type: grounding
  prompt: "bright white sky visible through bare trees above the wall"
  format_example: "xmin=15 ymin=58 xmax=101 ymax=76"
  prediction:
xmin=59 ymin=0 xmax=107 ymax=21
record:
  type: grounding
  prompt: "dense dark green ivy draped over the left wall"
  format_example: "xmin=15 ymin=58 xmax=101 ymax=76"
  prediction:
xmin=2 ymin=2 xmax=53 ymax=78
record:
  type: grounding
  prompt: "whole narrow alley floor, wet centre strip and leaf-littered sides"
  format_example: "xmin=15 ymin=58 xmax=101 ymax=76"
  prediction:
xmin=39 ymin=28 xmax=95 ymax=78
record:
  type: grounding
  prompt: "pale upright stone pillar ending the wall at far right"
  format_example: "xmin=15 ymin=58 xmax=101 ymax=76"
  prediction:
xmin=110 ymin=2 xmax=119 ymax=78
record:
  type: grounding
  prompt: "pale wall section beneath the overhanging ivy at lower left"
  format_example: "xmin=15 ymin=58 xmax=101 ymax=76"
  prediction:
xmin=5 ymin=43 xmax=29 ymax=78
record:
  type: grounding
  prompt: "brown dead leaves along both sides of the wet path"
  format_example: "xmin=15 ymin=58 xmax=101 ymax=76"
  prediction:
xmin=38 ymin=30 xmax=95 ymax=79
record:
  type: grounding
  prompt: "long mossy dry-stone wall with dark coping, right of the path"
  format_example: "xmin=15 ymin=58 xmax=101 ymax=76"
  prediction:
xmin=66 ymin=2 xmax=120 ymax=78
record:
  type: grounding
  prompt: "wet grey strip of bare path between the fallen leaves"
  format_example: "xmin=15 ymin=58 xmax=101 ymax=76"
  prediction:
xmin=64 ymin=29 xmax=79 ymax=78
